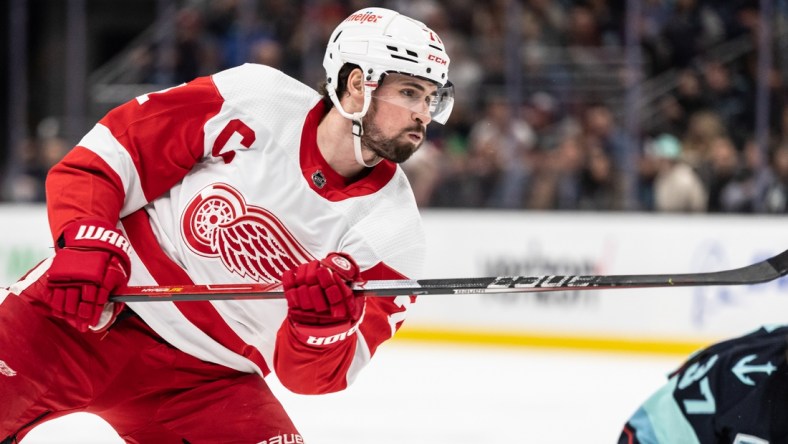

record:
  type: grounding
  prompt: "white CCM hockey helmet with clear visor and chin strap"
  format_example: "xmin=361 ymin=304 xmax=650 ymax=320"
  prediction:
xmin=323 ymin=8 xmax=454 ymax=124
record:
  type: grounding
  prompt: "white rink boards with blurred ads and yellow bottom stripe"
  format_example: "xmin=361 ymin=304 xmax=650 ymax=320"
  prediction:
xmin=0 ymin=206 xmax=788 ymax=354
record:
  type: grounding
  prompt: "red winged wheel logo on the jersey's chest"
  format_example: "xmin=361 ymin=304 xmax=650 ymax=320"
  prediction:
xmin=181 ymin=183 xmax=312 ymax=283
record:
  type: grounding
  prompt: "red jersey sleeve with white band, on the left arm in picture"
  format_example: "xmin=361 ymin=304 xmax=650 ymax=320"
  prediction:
xmin=46 ymin=77 xmax=223 ymax=238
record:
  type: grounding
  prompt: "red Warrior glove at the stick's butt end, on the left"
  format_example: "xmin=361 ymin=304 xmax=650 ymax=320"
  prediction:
xmin=47 ymin=219 xmax=131 ymax=332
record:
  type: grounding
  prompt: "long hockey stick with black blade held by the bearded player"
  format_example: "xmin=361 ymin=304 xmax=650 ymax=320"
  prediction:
xmin=112 ymin=250 xmax=788 ymax=302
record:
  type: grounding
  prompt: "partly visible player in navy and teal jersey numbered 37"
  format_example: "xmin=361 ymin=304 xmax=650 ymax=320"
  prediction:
xmin=618 ymin=326 xmax=788 ymax=444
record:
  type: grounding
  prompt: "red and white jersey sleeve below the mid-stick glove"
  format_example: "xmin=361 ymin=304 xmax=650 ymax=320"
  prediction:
xmin=274 ymin=263 xmax=415 ymax=394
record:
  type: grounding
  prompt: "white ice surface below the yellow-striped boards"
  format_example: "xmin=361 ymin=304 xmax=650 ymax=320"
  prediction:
xmin=22 ymin=341 xmax=682 ymax=444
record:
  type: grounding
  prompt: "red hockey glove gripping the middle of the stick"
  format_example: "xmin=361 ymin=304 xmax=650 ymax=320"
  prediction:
xmin=282 ymin=253 xmax=365 ymax=337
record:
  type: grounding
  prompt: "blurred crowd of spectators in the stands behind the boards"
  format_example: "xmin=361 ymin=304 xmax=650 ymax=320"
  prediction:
xmin=6 ymin=0 xmax=788 ymax=213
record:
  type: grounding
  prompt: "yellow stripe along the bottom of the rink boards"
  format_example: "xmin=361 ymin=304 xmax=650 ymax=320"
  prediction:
xmin=395 ymin=326 xmax=713 ymax=356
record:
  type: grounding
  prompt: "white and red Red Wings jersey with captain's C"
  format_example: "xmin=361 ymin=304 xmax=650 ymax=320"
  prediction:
xmin=47 ymin=64 xmax=425 ymax=393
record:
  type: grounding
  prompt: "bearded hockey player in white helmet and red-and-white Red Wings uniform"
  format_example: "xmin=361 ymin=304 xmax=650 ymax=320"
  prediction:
xmin=0 ymin=8 xmax=453 ymax=444
